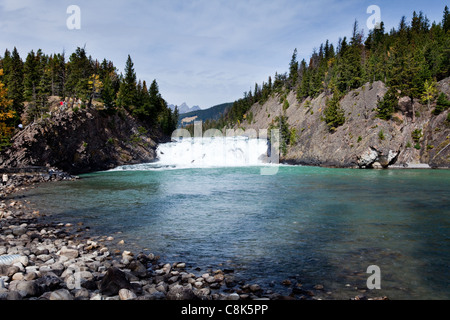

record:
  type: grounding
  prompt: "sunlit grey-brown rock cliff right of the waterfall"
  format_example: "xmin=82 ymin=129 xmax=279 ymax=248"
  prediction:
xmin=236 ymin=78 xmax=450 ymax=168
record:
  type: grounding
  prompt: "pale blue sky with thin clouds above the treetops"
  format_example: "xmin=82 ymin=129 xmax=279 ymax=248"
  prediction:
xmin=0 ymin=0 xmax=444 ymax=109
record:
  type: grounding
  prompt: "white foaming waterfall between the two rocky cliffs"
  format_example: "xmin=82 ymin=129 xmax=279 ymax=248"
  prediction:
xmin=114 ymin=137 xmax=268 ymax=171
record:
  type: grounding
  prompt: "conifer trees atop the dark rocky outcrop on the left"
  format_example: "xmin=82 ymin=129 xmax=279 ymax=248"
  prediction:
xmin=0 ymin=47 xmax=178 ymax=149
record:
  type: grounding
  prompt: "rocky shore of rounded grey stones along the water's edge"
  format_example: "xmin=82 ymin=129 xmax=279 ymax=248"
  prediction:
xmin=0 ymin=172 xmax=384 ymax=301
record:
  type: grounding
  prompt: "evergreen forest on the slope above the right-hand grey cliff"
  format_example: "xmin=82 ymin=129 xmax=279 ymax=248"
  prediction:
xmin=211 ymin=6 xmax=450 ymax=131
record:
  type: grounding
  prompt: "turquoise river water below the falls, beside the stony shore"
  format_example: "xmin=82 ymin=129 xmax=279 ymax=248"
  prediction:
xmin=22 ymin=166 xmax=450 ymax=299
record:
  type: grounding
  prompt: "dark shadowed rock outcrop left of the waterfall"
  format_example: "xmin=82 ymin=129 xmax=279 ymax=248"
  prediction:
xmin=0 ymin=108 xmax=169 ymax=174
